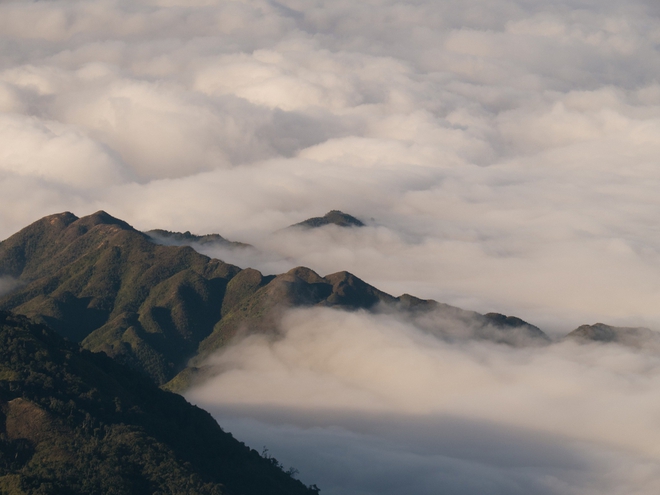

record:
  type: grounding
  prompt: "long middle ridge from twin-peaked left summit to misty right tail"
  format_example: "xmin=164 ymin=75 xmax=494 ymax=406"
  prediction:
xmin=0 ymin=211 xmax=547 ymax=389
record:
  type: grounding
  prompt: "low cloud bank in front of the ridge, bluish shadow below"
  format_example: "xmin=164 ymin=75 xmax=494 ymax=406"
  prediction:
xmin=187 ymin=309 xmax=660 ymax=495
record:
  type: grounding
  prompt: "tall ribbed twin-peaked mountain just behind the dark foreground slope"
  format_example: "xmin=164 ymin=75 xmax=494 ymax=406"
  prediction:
xmin=0 ymin=212 xmax=240 ymax=383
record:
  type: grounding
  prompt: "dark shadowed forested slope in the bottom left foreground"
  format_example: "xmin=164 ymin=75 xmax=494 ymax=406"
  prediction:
xmin=0 ymin=312 xmax=318 ymax=495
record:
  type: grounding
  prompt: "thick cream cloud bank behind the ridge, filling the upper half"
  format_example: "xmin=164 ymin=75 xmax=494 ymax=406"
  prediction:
xmin=0 ymin=0 xmax=660 ymax=331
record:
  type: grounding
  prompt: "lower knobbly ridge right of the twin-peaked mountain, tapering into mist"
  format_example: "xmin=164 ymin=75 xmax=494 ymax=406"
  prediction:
xmin=165 ymin=274 xmax=550 ymax=392
